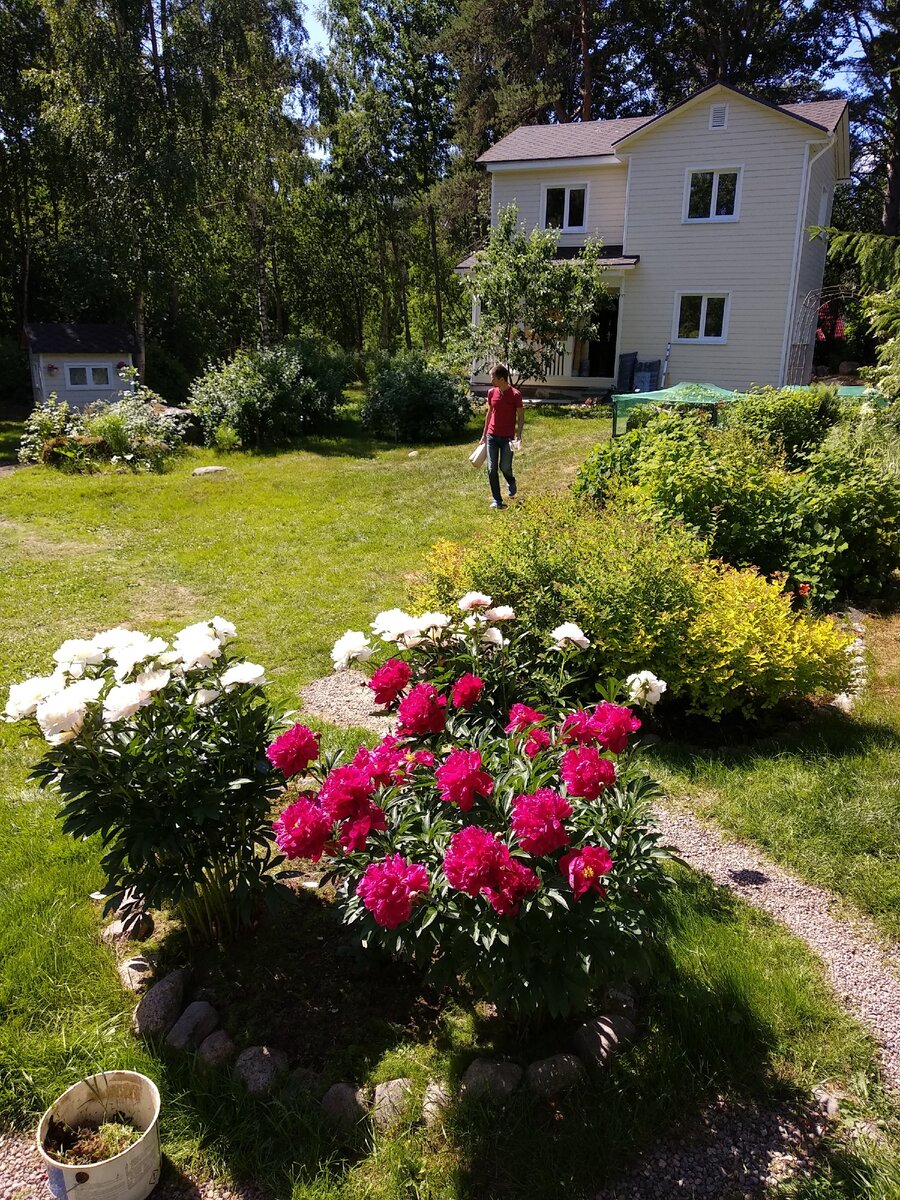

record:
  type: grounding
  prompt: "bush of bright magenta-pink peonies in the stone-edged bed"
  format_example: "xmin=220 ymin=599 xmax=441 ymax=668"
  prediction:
xmin=270 ymin=672 xmax=666 ymax=1019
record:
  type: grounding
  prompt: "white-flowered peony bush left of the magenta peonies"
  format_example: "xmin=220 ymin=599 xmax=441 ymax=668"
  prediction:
xmin=4 ymin=617 xmax=280 ymax=941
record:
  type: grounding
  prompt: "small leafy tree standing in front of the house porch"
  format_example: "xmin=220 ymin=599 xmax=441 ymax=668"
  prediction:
xmin=467 ymin=204 xmax=607 ymax=382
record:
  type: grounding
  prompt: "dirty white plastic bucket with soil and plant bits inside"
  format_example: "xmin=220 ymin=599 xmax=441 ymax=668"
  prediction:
xmin=37 ymin=1070 xmax=160 ymax=1200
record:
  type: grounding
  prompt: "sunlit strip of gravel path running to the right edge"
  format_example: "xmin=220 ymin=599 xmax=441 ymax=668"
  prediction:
xmin=656 ymin=808 xmax=900 ymax=1091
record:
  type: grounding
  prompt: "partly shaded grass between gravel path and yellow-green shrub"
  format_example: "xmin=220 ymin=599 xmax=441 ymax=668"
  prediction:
xmin=653 ymin=614 xmax=900 ymax=941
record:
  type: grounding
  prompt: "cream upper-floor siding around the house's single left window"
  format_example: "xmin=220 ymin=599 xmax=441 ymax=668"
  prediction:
xmin=491 ymin=163 xmax=628 ymax=246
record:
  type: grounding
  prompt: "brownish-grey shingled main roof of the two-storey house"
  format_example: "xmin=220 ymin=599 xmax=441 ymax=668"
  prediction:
xmin=478 ymin=84 xmax=847 ymax=163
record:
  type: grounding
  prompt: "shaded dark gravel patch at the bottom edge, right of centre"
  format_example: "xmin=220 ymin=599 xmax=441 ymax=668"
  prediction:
xmin=594 ymin=1097 xmax=824 ymax=1200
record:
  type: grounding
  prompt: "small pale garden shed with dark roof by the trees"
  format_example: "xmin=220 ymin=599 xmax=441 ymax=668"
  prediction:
xmin=25 ymin=322 xmax=136 ymax=408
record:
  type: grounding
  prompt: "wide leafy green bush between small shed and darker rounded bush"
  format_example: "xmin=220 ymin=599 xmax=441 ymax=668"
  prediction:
xmin=190 ymin=346 xmax=336 ymax=449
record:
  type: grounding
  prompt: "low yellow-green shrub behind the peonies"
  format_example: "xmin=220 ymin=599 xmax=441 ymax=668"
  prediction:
xmin=416 ymin=499 xmax=850 ymax=719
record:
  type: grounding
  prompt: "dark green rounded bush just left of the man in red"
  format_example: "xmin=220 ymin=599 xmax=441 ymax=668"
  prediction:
xmin=361 ymin=353 xmax=472 ymax=442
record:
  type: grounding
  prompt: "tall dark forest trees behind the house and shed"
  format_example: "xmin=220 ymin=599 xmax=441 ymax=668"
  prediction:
xmin=0 ymin=0 xmax=900 ymax=402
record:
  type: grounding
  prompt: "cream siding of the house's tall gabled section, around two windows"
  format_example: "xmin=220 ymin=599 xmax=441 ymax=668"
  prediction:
xmin=619 ymin=94 xmax=822 ymax=389
